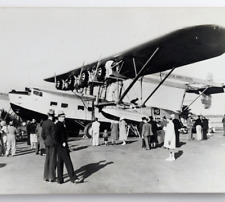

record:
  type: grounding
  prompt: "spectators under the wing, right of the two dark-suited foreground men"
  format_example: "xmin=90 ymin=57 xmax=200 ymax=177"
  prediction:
xmin=87 ymin=114 xmax=212 ymax=161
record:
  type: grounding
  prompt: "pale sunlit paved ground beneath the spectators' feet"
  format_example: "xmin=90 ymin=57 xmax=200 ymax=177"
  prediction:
xmin=0 ymin=133 xmax=225 ymax=194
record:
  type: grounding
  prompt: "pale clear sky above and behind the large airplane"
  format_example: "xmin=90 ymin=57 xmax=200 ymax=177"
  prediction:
xmin=0 ymin=4 xmax=225 ymax=114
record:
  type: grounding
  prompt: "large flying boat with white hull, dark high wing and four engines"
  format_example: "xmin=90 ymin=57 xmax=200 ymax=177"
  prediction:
xmin=9 ymin=25 xmax=225 ymax=137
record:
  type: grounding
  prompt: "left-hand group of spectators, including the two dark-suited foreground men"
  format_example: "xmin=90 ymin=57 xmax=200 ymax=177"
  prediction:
xmin=0 ymin=109 xmax=84 ymax=184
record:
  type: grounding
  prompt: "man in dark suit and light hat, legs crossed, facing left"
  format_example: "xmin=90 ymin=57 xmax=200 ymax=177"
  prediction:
xmin=55 ymin=111 xmax=83 ymax=184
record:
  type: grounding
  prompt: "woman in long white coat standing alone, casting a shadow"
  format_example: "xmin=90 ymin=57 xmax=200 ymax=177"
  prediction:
xmin=164 ymin=119 xmax=176 ymax=161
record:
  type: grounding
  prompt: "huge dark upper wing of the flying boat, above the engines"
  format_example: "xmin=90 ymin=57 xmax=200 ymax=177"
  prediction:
xmin=44 ymin=25 xmax=225 ymax=87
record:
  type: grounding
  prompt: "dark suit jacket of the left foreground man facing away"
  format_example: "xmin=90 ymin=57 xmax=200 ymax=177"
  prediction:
xmin=41 ymin=119 xmax=55 ymax=146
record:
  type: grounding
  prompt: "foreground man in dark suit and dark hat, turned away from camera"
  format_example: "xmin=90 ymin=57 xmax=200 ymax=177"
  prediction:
xmin=41 ymin=109 xmax=56 ymax=182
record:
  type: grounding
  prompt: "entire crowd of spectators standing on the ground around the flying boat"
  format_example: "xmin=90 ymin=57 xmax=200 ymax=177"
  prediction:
xmin=0 ymin=109 xmax=216 ymax=184
